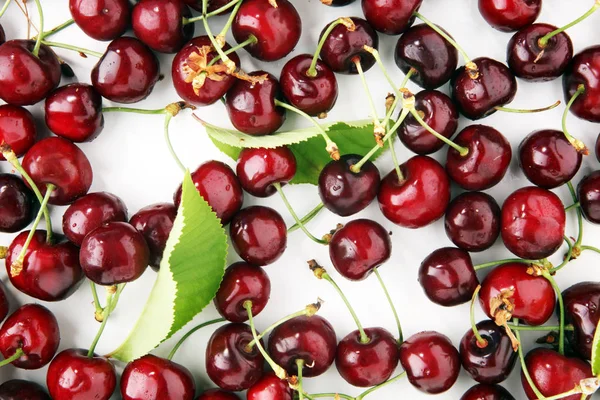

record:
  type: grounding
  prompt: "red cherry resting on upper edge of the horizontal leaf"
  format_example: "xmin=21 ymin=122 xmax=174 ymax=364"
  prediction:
xmin=225 ymin=71 xmax=285 ymax=136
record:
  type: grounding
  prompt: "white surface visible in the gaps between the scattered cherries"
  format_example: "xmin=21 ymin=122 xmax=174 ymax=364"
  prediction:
xmin=0 ymin=0 xmax=600 ymax=400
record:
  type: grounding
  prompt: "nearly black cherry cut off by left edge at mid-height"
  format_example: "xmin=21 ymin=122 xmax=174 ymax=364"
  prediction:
xmin=0 ymin=174 xmax=39 ymax=233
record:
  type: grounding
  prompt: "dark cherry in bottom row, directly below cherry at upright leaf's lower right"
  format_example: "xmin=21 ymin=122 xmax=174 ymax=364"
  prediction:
xmin=205 ymin=323 xmax=264 ymax=392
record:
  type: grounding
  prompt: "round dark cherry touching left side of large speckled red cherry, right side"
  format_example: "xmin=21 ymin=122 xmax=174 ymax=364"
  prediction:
xmin=444 ymin=192 xmax=500 ymax=251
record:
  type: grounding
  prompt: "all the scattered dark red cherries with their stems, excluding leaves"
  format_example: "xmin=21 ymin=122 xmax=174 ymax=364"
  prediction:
xmin=0 ymin=0 xmax=600 ymax=400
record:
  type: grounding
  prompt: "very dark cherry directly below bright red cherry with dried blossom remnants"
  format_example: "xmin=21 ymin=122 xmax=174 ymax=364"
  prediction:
xmin=459 ymin=320 xmax=517 ymax=385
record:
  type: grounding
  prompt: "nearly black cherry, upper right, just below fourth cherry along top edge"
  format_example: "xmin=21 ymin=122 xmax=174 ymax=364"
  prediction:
xmin=394 ymin=24 xmax=458 ymax=89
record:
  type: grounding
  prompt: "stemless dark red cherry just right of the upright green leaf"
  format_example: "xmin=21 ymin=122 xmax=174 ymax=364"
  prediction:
xmin=229 ymin=206 xmax=287 ymax=266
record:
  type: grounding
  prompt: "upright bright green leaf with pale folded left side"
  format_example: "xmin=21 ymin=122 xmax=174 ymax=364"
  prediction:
xmin=111 ymin=173 xmax=227 ymax=362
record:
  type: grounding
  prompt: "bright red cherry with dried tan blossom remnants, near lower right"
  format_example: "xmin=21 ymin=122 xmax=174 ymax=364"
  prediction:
xmin=479 ymin=263 xmax=556 ymax=325
